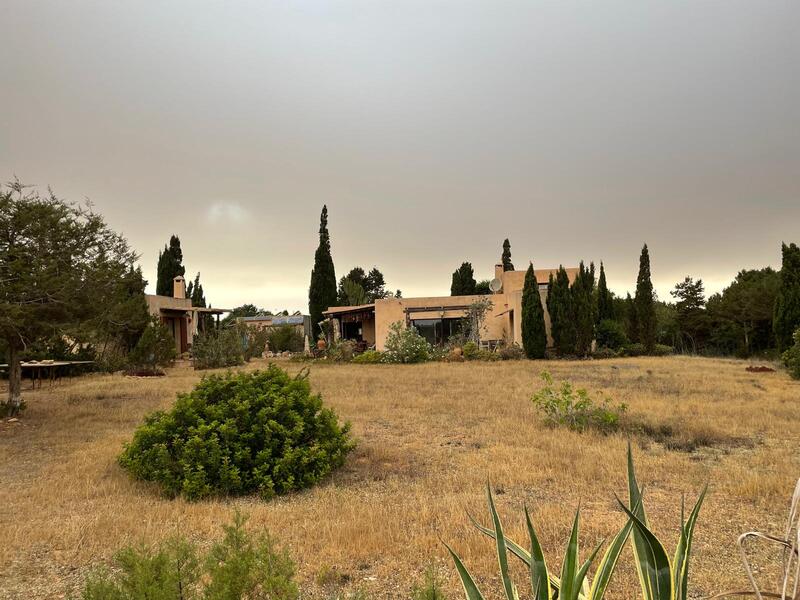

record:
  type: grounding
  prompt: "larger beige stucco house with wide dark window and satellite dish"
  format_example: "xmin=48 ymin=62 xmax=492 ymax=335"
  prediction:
xmin=324 ymin=265 xmax=578 ymax=350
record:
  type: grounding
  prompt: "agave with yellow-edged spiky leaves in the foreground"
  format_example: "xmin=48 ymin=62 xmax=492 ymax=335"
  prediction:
xmin=445 ymin=444 xmax=706 ymax=600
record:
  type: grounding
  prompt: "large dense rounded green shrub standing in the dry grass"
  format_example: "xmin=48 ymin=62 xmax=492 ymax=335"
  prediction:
xmin=119 ymin=365 xmax=355 ymax=500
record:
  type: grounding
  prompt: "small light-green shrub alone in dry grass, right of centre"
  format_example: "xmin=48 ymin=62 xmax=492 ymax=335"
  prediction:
xmin=531 ymin=371 xmax=627 ymax=433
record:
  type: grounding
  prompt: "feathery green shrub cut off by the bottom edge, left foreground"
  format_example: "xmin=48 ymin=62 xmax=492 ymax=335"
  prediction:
xmin=81 ymin=513 xmax=300 ymax=600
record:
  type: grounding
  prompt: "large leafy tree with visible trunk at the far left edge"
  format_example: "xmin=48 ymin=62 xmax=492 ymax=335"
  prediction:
xmin=0 ymin=181 xmax=141 ymax=414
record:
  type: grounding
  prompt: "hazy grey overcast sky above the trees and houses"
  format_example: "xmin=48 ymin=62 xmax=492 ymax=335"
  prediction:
xmin=0 ymin=0 xmax=800 ymax=312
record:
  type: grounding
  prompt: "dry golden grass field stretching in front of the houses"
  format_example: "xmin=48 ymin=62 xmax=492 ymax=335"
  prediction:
xmin=0 ymin=357 xmax=800 ymax=599
